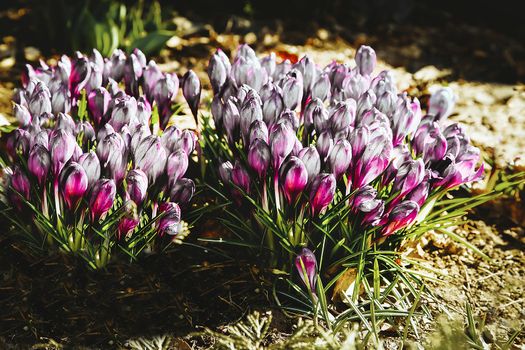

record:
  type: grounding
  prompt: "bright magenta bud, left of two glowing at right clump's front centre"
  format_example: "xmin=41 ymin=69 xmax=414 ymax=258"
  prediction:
xmin=279 ymin=156 xmax=308 ymax=204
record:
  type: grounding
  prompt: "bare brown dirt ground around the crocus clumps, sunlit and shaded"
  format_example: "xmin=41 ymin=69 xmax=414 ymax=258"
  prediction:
xmin=0 ymin=6 xmax=525 ymax=349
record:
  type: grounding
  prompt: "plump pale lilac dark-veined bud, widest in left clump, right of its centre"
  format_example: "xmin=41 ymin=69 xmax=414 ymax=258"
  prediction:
xmin=134 ymin=135 xmax=168 ymax=184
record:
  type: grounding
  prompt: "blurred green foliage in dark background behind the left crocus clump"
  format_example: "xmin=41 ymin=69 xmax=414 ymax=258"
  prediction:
xmin=32 ymin=0 xmax=174 ymax=56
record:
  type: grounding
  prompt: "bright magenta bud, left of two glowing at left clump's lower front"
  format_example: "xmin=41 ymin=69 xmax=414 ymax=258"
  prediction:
xmin=60 ymin=162 xmax=88 ymax=210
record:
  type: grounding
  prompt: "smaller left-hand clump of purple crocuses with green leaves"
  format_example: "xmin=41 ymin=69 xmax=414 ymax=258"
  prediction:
xmin=6 ymin=50 xmax=201 ymax=267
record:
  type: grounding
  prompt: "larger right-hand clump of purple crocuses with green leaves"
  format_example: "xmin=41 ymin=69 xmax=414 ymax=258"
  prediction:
xmin=203 ymin=45 xmax=483 ymax=322
